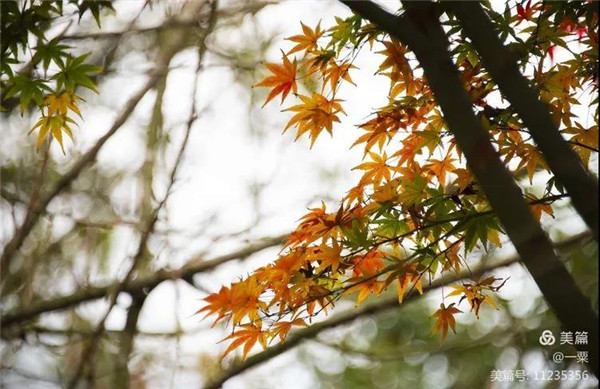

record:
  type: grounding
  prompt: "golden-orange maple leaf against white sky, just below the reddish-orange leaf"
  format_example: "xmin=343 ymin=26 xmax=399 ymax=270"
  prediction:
xmin=283 ymin=93 xmax=345 ymax=147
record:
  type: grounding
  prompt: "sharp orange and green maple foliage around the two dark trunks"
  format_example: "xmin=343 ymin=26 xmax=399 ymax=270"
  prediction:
xmin=199 ymin=2 xmax=598 ymax=357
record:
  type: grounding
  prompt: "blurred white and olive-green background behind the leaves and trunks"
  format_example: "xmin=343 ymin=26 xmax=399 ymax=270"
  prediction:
xmin=0 ymin=0 xmax=598 ymax=388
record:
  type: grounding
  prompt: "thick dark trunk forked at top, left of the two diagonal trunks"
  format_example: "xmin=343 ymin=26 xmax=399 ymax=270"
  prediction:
xmin=342 ymin=0 xmax=598 ymax=375
